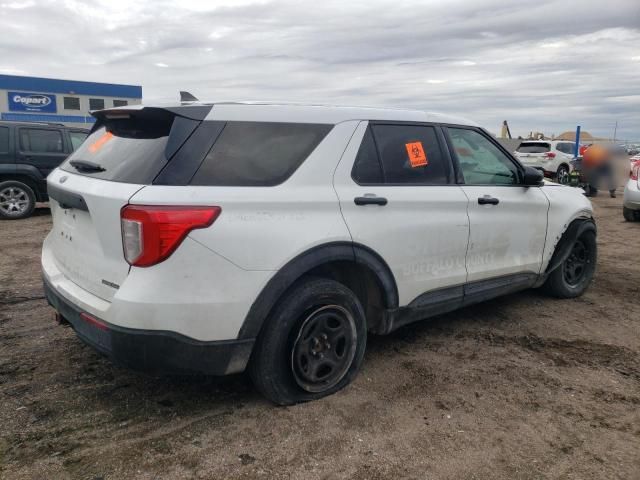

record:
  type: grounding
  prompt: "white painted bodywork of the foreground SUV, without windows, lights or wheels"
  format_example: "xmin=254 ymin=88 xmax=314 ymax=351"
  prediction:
xmin=42 ymin=104 xmax=591 ymax=341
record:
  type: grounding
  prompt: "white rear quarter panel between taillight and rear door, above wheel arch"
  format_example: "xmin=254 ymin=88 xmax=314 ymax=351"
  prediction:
xmin=131 ymin=121 xmax=358 ymax=270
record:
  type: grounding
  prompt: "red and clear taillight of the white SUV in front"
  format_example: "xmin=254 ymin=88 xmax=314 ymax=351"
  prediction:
xmin=120 ymin=205 xmax=222 ymax=267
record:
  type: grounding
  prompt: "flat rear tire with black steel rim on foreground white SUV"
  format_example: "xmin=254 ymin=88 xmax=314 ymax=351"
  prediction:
xmin=249 ymin=277 xmax=367 ymax=405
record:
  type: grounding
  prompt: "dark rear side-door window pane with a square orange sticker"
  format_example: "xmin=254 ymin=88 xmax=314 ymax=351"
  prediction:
xmin=371 ymin=124 xmax=451 ymax=185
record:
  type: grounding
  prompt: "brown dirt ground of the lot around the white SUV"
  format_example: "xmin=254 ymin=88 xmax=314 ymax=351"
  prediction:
xmin=0 ymin=172 xmax=640 ymax=480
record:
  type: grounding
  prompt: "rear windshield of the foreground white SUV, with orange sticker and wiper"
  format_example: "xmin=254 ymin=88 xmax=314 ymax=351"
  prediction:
xmin=61 ymin=115 xmax=174 ymax=184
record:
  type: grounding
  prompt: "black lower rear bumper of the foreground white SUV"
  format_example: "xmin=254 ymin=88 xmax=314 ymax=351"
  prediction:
xmin=44 ymin=279 xmax=254 ymax=375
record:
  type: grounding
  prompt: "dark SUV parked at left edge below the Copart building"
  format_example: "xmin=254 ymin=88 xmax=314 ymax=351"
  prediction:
xmin=0 ymin=121 xmax=89 ymax=220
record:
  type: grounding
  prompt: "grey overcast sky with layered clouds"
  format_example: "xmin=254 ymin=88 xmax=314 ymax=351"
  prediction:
xmin=0 ymin=0 xmax=640 ymax=140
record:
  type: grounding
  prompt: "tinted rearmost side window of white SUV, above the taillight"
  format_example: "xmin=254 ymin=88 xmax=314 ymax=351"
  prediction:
xmin=191 ymin=122 xmax=333 ymax=186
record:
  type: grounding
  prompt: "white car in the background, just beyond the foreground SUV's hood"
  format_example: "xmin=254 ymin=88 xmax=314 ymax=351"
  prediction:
xmin=515 ymin=140 xmax=576 ymax=184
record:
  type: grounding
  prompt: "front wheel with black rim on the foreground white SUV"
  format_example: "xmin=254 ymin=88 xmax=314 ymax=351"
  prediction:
xmin=543 ymin=230 xmax=598 ymax=298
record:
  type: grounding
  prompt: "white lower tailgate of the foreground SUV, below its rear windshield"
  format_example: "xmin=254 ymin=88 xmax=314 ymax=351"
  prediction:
xmin=48 ymin=169 xmax=143 ymax=301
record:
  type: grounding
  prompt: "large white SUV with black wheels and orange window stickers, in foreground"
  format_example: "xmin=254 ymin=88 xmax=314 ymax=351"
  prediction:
xmin=42 ymin=103 xmax=596 ymax=404
